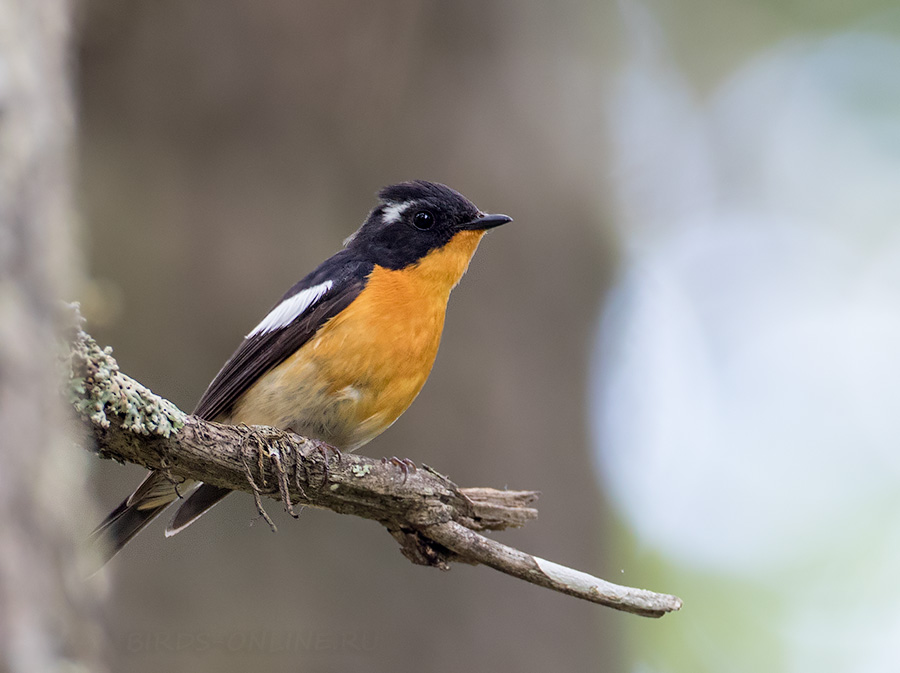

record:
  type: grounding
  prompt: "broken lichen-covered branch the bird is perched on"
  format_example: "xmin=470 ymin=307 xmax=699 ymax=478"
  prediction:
xmin=65 ymin=308 xmax=681 ymax=617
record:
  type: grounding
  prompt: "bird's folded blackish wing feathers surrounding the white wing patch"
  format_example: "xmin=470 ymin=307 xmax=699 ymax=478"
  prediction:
xmin=194 ymin=249 xmax=372 ymax=420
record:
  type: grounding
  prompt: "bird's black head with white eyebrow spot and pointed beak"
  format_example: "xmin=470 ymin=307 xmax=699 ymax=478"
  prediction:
xmin=345 ymin=180 xmax=512 ymax=269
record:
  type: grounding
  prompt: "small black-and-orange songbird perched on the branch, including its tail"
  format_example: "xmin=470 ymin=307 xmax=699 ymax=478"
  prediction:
xmin=91 ymin=180 xmax=512 ymax=560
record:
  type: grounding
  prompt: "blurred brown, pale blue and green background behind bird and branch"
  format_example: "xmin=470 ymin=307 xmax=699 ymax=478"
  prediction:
xmin=77 ymin=0 xmax=900 ymax=672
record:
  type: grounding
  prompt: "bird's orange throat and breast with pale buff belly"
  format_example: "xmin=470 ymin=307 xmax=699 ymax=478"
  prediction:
xmin=231 ymin=231 xmax=483 ymax=449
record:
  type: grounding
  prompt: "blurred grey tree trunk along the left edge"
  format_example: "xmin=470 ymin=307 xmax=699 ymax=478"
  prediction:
xmin=0 ymin=0 xmax=100 ymax=673
